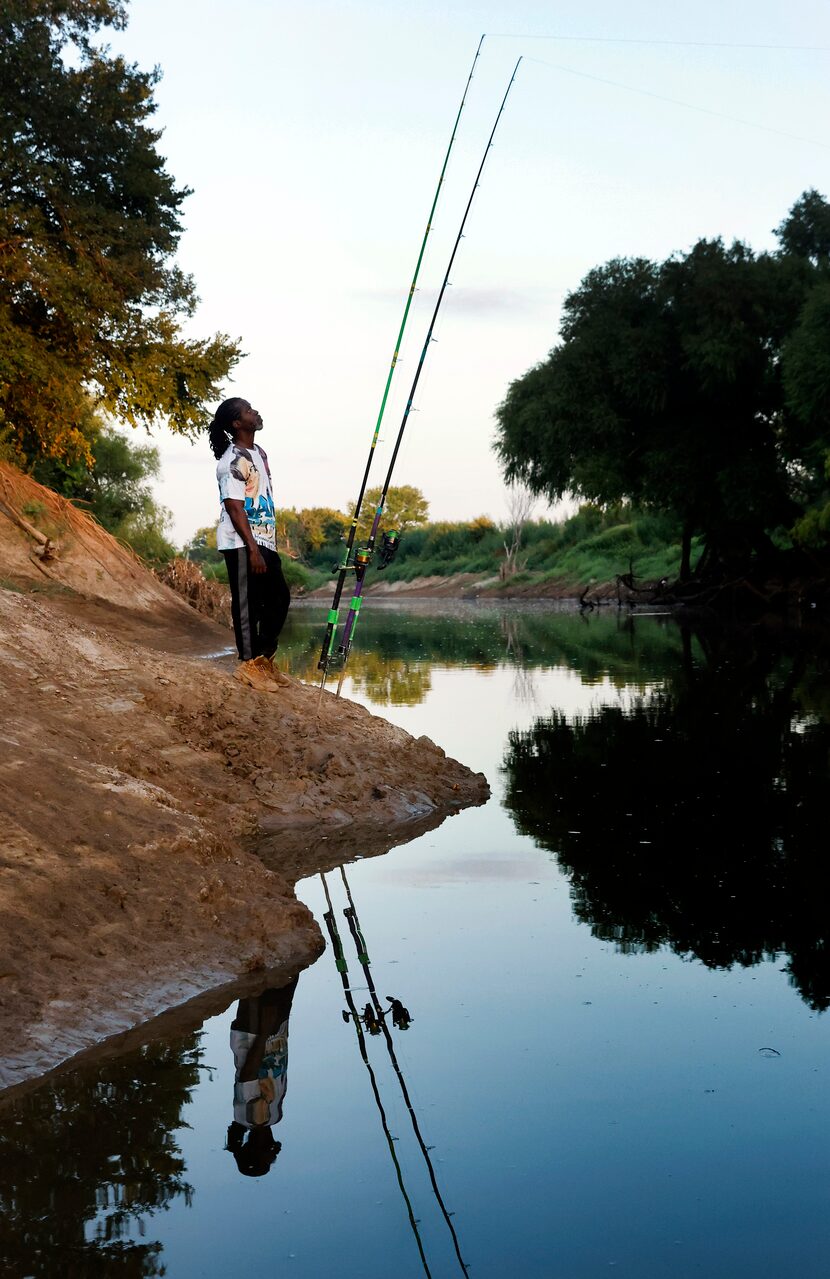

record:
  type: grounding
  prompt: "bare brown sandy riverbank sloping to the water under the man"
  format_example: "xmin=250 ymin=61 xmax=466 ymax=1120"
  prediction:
xmin=0 ymin=468 xmax=487 ymax=1087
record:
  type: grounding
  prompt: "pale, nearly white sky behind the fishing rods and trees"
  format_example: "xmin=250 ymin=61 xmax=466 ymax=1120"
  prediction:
xmin=110 ymin=0 xmax=830 ymax=544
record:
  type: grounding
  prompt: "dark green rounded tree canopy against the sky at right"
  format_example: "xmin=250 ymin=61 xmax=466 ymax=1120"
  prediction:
xmin=496 ymin=191 xmax=830 ymax=573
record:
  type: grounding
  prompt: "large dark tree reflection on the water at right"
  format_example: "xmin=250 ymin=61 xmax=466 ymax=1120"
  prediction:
xmin=504 ymin=629 xmax=830 ymax=1009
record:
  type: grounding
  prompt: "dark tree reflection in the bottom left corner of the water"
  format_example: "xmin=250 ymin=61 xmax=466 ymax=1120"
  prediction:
xmin=0 ymin=1035 xmax=200 ymax=1279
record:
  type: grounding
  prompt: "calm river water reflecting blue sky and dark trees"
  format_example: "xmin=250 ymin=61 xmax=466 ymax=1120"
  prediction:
xmin=0 ymin=601 xmax=830 ymax=1279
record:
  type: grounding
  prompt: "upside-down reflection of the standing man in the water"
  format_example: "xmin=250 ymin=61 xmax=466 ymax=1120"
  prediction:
xmin=226 ymin=977 xmax=297 ymax=1177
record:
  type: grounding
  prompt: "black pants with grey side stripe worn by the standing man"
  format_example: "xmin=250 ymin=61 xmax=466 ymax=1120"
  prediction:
xmin=223 ymin=546 xmax=292 ymax=661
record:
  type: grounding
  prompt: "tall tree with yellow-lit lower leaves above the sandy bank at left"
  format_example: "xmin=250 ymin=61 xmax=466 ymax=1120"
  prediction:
xmin=0 ymin=0 xmax=239 ymax=463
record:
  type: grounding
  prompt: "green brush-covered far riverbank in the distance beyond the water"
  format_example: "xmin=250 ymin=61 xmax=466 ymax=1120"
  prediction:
xmin=166 ymin=503 xmax=830 ymax=615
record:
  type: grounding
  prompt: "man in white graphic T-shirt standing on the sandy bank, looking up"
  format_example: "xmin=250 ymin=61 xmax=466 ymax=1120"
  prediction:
xmin=208 ymin=398 xmax=290 ymax=691
